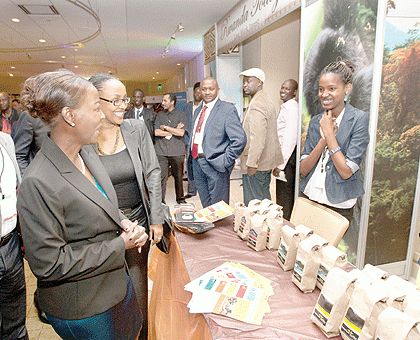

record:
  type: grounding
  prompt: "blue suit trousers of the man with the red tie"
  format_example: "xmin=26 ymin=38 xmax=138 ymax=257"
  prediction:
xmin=192 ymin=158 xmax=230 ymax=208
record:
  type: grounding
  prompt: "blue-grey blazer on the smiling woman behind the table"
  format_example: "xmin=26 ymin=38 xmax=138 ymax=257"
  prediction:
xmin=300 ymin=103 xmax=369 ymax=203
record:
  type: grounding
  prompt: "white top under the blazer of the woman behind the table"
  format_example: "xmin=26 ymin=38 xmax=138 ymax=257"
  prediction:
xmin=303 ymin=109 xmax=357 ymax=209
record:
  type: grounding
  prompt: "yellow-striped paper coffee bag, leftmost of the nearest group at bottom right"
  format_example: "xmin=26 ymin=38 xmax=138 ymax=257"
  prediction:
xmin=311 ymin=267 xmax=356 ymax=338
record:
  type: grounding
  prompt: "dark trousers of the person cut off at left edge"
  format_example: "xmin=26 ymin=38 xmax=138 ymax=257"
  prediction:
xmin=0 ymin=230 xmax=28 ymax=340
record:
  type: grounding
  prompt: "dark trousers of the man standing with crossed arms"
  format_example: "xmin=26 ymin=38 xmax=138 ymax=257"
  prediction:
xmin=157 ymin=155 xmax=185 ymax=202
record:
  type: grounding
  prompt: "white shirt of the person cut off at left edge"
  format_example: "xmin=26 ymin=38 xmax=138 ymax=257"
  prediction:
xmin=0 ymin=145 xmax=17 ymax=237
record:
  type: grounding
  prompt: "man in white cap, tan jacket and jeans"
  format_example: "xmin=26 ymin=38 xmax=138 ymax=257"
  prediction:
xmin=239 ymin=68 xmax=283 ymax=205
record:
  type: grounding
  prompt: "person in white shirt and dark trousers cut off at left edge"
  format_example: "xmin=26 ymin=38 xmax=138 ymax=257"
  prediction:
xmin=0 ymin=132 xmax=28 ymax=339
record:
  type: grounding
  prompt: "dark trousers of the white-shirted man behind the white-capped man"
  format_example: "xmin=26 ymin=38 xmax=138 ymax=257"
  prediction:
xmin=276 ymin=148 xmax=296 ymax=221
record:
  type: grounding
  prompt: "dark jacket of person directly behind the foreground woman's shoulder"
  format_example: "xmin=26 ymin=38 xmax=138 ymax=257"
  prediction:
xmin=13 ymin=111 xmax=47 ymax=176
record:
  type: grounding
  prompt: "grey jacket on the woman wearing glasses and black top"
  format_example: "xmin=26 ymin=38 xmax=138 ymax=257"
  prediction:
xmin=84 ymin=119 xmax=163 ymax=224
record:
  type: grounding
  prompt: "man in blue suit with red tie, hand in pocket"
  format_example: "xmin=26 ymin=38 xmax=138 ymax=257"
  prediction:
xmin=188 ymin=78 xmax=246 ymax=207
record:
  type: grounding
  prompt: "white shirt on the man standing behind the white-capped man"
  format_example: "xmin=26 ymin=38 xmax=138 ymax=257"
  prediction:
xmin=277 ymin=98 xmax=299 ymax=170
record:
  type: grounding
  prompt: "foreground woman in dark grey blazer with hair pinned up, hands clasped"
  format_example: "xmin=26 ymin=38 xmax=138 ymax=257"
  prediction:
xmin=18 ymin=70 xmax=147 ymax=340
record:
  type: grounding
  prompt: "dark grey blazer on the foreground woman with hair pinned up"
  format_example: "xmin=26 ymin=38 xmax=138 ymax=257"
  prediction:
xmin=18 ymin=137 xmax=127 ymax=320
